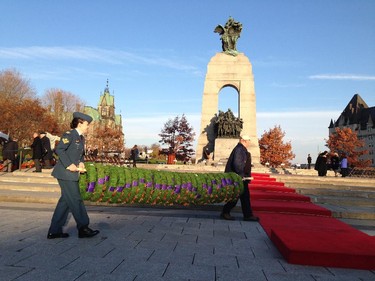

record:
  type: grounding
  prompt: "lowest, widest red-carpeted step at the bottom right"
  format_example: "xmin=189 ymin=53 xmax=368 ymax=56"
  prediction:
xmin=256 ymin=212 xmax=375 ymax=270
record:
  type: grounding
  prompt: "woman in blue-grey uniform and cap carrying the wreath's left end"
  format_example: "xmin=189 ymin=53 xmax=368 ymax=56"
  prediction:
xmin=47 ymin=112 xmax=99 ymax=239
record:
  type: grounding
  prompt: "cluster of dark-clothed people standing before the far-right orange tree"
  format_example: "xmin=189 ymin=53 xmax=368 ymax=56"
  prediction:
xmin=314 ymin=151 xmax=349 ymax=177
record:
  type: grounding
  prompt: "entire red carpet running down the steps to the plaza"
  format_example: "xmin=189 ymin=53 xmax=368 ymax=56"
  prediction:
xmin=249 ymin=174 xmax=375 ymax=270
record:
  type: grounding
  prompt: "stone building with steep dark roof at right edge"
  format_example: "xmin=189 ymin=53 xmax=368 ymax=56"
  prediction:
xmin=328 ymin=94 xmax=375 ymax=167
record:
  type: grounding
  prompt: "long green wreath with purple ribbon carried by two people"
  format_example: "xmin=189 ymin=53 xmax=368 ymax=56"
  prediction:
xmin=79 ymin=163 xmax=244 ymax=206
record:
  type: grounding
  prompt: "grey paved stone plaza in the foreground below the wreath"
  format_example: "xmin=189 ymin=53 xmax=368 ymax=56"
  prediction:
xmin=0 ymin=202 xmax=375 ymax=281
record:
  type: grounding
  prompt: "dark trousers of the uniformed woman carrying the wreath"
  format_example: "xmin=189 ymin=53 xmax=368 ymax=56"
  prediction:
xmin=48 ymin=180 xmax=89 ymax=233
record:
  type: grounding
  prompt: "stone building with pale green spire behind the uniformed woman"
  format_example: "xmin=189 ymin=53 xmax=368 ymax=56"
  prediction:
xmin=84 ymin=80 xmax=124 ymax=155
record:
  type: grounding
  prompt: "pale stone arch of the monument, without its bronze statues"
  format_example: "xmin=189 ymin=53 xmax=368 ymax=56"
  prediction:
xmin=196 ymin=53 xmax=260 ymax=164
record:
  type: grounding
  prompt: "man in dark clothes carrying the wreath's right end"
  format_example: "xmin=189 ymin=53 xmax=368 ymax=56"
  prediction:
xmin=220 ymin=135 xmax=259 ymax=221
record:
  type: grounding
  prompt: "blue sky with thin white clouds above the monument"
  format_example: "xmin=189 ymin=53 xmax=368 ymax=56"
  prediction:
xmin=0 ymin=0 xmax=375 ymax=163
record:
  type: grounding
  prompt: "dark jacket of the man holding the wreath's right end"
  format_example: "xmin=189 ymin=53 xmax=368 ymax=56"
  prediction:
xmin=225 ymin=143 xmax=251 ymax=177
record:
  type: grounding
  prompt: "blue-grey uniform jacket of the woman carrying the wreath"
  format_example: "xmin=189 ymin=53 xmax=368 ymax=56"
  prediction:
xmin=52 ymin=129 xmax=85 ymax=181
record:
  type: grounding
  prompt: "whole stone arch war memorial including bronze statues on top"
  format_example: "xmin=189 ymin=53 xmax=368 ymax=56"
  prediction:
xmin=196 ymin=17 xmax=260 ymax=165
